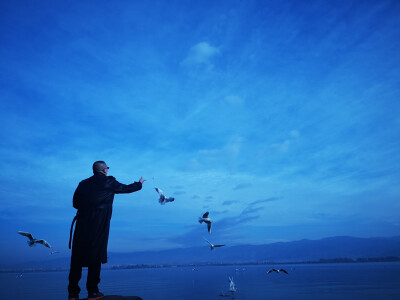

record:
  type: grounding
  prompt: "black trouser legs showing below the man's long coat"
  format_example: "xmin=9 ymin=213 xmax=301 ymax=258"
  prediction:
xmin=68 ymin=260 xmax=101 ymax=294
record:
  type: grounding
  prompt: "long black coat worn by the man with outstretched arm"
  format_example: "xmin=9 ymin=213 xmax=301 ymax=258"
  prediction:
xmin=71 ymin=173 xmax=142 ymax=267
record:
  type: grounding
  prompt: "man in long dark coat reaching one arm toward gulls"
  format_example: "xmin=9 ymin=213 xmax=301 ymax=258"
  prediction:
xmin=68 ymin=161 xmax=145 ymax=300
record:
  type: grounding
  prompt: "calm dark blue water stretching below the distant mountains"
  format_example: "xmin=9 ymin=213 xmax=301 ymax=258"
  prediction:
xmin=0 ymin=263 xmax=400 ymax=300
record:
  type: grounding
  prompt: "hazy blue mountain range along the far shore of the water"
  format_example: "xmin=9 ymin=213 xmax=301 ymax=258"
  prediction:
xmin=0 ymin=236 xmax=400 ymax=270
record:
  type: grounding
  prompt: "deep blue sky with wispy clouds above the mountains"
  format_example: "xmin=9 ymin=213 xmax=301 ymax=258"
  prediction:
xmin=0 ymin=0 xmax=400 ymax=261
